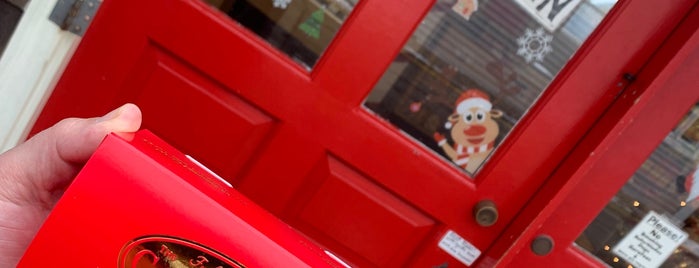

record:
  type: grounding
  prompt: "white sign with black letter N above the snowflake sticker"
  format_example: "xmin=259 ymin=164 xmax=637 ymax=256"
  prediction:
xmin=515 ymin=0 xmax=581 ymax=32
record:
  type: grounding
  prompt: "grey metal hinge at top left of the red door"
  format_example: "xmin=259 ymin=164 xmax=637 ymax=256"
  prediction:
xmin=49 ymin=0 xmax=102 ymax=36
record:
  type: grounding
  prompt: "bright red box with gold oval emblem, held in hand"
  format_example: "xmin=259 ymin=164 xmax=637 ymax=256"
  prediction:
xmin=19 ymin=130 xmax=346 ymax=268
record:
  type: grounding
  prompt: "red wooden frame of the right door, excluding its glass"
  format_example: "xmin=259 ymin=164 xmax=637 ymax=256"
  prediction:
xmin=486 ymin=4 xmax=699 ymax=267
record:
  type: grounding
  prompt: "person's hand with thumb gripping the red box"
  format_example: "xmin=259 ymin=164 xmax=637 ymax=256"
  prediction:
xmin=0 ymin=104 xmax=141 ymax=203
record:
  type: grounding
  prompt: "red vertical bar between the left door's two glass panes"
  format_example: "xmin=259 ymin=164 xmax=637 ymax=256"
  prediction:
xmin=312 ymin=0 xmax=434 ymax=107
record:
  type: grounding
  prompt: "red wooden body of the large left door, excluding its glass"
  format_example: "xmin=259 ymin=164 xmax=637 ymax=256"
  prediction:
xmin=33 ymin=0 xmax=694 ymax=267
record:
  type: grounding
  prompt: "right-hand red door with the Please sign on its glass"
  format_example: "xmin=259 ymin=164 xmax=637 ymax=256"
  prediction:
xmin=498 ymin=6 xmax=699 ymax=267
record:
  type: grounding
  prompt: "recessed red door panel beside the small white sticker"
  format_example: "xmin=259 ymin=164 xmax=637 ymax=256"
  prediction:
xmin=286 ymin=156 xmax=437 ymax=267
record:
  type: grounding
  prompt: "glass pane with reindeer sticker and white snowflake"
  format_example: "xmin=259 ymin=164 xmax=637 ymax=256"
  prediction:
xmin=364 ymin=0 xmax=615 ymax=175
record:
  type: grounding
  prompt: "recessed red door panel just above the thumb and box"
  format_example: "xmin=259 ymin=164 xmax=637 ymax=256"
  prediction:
xmin=118 ymin=45 xmax=276 ymax=178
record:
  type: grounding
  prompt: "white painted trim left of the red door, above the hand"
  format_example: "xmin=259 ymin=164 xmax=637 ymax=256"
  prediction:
xmin=0 ymin=0 xmax=80 ymax=152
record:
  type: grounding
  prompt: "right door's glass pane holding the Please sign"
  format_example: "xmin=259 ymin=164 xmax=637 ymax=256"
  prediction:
xmin=576 ymin=104 xmax=699 ymax=268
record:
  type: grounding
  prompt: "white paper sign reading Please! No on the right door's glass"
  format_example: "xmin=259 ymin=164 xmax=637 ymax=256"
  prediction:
xmin=612 ymin=211 xmax=688 ymax=268
